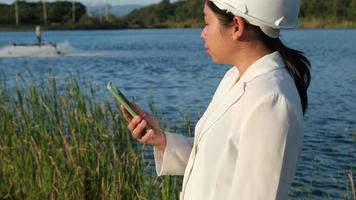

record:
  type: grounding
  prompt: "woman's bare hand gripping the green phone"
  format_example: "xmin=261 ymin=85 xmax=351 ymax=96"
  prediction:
xmin=120 ymin=104 xmax=166 ymax=151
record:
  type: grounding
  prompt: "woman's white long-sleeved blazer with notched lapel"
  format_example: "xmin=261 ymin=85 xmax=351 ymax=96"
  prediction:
xmin=154 ymin=52 xmax=303 ymax=200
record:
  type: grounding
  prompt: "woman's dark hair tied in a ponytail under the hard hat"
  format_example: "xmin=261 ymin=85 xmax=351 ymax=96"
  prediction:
xmin=206 ymin=0 xmax=311 ymax=114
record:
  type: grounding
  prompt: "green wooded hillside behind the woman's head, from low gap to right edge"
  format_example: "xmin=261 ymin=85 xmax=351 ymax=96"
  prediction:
xmin=124 ymin=0 xmax=356 ymax=28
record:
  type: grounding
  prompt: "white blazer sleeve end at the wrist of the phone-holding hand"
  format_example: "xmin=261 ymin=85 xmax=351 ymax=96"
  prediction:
xmin=153 ymin=132 xmax=194 ymax=176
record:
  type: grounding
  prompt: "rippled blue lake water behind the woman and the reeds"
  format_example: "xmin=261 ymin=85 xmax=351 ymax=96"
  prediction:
xmin=0 ymin=29 xmax=356 ymax=199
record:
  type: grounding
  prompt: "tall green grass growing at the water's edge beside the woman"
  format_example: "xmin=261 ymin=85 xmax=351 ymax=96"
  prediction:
xmin=0 ymin=78 xmax=181 ymax=199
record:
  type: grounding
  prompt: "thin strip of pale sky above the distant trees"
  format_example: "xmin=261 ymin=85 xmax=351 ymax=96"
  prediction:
xmin=0 ymin=0 xmax=161 ymax=5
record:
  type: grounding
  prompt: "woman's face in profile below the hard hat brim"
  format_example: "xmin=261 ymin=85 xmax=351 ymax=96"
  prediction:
xmin=201 ymin=4 xmax=232 ymax=64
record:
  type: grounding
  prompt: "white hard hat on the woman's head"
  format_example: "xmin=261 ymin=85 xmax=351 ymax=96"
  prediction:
xmin=210 ymin=0 xmax=300 ymax=38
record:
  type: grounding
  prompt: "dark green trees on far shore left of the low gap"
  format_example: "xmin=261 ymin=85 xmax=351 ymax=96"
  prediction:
xmin=0 ymin=0 xmax=127 ymax=29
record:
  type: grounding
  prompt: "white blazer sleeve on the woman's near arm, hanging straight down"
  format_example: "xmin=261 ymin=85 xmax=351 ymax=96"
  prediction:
xmin=229 ymin=95 xmax=303 ymax=200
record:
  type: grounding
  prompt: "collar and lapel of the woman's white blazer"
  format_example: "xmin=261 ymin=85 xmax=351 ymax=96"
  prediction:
xmin=196 ymin=52 xmax=284 ymax=142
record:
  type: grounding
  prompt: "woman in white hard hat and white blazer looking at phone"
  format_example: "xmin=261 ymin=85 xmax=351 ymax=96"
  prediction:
xmin=121 ymin=0 xmax=310 ymax=200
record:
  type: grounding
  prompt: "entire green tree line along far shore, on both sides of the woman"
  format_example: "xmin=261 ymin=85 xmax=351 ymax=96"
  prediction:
xmin=0 ymin=0 xmax=356 ymax=28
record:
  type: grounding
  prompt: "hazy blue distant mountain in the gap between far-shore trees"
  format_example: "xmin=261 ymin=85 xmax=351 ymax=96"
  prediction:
xmin=87 ymin=4 xmax=142 ymax=17
